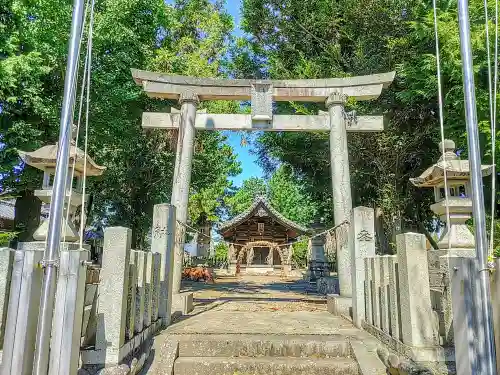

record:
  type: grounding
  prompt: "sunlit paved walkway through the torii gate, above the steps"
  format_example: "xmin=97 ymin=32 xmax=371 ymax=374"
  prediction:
xmin=169 ymin=276 xmax=359 ymax=335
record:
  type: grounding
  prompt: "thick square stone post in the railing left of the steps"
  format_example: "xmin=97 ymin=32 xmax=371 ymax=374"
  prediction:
xmin=96 ymin=227 xmax=132 ymax=365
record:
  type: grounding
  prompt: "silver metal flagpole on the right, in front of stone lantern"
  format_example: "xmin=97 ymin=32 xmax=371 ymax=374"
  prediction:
xmin=458 ymin=0 xmax=496 ymax=375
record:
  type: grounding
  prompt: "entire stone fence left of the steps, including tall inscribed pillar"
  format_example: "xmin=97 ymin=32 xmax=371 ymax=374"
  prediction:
xmin=0 ymin=204 xmax=176 ymax=375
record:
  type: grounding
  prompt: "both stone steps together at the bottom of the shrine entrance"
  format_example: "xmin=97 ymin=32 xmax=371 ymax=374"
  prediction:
xmin=166 ymin=334 xmax=374 ymax=375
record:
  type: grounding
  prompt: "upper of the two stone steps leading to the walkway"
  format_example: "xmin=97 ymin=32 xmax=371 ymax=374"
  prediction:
xmin=176 ymin=334 xmax=352 ymax=358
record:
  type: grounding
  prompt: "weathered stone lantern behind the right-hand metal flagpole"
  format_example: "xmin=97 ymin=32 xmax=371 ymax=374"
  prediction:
xmin=410 ymin=139 xmax=492 ymax=249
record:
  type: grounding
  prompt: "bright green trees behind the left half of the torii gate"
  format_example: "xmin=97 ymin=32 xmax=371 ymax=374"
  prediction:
xmin=0 ymin=0 xmax=239 ymax=247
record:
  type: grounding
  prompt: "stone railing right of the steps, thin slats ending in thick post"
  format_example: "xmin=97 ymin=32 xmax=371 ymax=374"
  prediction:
xmin=362 ymin=233 xmax=450 ymax=363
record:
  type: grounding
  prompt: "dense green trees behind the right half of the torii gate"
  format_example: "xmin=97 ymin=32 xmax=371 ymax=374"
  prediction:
xmin=239 ymin=0 xmax=500 ymax=233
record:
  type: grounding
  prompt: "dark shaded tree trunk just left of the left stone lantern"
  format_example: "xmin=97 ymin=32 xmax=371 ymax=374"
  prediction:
xmin=14 ymin=190 xmax=42 ymax=242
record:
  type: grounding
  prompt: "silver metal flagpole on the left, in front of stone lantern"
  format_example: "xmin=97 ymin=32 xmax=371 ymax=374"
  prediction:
xmin=33 ymin=0 xmax=84 ymax=375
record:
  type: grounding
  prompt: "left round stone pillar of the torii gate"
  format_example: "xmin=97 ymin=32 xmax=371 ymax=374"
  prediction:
xmin=171 ymin=92 xmax=199 ymax=294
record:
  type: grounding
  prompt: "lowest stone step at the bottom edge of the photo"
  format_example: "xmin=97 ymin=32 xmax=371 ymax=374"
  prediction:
xmin=174 ymin=357 xmax=359 ymax=375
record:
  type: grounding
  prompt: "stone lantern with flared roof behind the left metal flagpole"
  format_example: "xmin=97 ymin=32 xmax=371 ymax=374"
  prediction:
xmin=18 ymin=137 xmax=106 ymax=242
